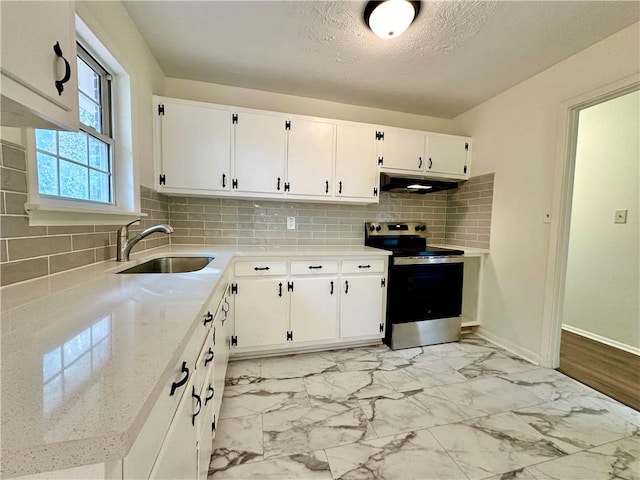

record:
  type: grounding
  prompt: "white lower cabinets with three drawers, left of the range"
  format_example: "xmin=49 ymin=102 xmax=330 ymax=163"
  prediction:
xmin=232 ymin=257 xmax=387 ymax=353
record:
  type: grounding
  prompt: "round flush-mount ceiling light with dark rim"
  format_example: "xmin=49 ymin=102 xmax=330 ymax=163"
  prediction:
xmin=364 ymin=0 xmax=420 ymax=40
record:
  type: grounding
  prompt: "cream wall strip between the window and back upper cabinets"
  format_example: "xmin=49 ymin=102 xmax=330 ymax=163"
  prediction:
xmin=76 ymin=1 xmax=165 ymax=187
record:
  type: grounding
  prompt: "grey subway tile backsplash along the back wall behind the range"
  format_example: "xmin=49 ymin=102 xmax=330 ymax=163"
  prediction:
xmin=169 ymin=192 xmax=447 ymax=246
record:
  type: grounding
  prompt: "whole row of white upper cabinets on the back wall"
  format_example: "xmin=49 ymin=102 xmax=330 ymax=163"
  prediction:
xmin=155 ymin=97 xmax=471 ymax=204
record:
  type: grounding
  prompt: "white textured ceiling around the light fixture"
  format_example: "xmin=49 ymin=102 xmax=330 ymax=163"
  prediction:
xmin=124 ymin=0 xmax=640 ymax=118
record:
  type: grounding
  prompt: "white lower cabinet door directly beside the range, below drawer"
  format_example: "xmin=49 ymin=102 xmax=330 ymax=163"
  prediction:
xmin=340 ymin=275 xmax=385 ymax=338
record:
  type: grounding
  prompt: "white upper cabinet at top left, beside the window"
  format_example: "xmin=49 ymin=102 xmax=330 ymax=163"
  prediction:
xmin=0 ymin=1 xmax=79 ymax=130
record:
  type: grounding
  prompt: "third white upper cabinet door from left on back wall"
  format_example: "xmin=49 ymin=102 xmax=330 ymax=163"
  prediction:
xmin=287 ymin=119 xmax=335 ymax=196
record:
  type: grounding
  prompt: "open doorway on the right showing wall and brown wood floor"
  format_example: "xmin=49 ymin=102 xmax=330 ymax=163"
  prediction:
xmin=558 ymin=86 xmax=640 ymax=410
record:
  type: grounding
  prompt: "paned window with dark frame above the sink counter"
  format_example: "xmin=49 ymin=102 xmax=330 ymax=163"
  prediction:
xmin=35 ymin=45 xmax=114 ymax=204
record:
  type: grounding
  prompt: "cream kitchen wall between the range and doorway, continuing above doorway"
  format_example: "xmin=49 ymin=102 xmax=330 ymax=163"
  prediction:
xmin=453 ymin=23 xmax=640 ymax=361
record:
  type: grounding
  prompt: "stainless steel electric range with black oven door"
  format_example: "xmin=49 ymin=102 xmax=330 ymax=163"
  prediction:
xmin=365 ymin=222 xmax=464 ymax=350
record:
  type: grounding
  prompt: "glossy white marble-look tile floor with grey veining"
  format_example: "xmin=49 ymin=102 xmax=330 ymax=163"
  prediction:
xmin=209 ymin=335 xmax=640 ymax=480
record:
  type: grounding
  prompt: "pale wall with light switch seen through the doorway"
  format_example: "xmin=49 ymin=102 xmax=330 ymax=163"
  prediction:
xmin=562 ymin=91 xmax=640 ymax=351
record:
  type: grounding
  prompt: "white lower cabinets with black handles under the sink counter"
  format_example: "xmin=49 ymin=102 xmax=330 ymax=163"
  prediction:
xmin=122 ymin=283 xmax=232 ymax=480
